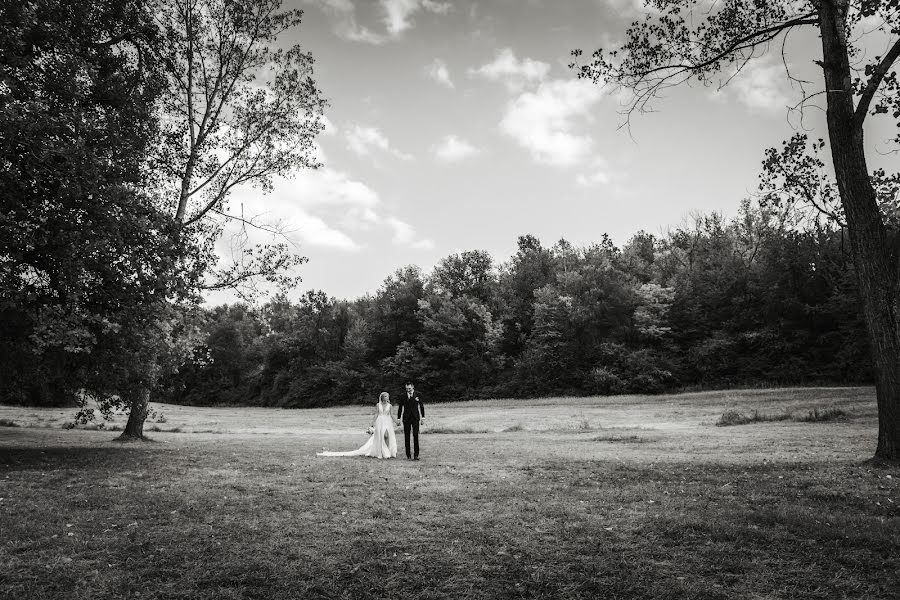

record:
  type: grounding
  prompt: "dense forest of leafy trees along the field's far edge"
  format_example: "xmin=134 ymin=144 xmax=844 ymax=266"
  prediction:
xmin=155 ymin=201 xmax=873 ymax=407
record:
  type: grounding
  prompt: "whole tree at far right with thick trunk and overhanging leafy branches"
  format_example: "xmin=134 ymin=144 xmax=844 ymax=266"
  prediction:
xmin=573 ymin=0 xmax=900 ymax=461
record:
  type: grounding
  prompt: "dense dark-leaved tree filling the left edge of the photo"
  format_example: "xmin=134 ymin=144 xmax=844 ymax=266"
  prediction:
xmin=0 ymin=0 xmax=188 ymax=402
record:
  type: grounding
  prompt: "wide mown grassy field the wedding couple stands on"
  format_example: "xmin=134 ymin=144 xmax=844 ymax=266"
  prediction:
xmin=0 ymin=388 xmax=900 ymax=599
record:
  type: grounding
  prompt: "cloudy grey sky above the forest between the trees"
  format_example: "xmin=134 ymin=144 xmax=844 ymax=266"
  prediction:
xmin=208 ymin=0 xmax=888 ymax=303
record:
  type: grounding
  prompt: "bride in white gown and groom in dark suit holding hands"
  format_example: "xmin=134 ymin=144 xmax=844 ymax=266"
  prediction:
xmin=316 ymin=382 xmax=425 ymax=460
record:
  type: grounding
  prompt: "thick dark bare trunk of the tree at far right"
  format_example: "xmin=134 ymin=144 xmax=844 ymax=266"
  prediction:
xmin=819 ymin=0 xmax=900 ymax=461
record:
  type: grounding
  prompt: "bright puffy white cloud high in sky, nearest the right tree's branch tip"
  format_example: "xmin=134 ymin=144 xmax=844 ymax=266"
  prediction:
xmin=500 ymin=79 xmax=603 ymax=167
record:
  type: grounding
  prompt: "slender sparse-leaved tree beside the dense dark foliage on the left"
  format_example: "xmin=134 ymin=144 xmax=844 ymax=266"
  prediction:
xmin=122 ymin=0 xmax=325 ymax=438
